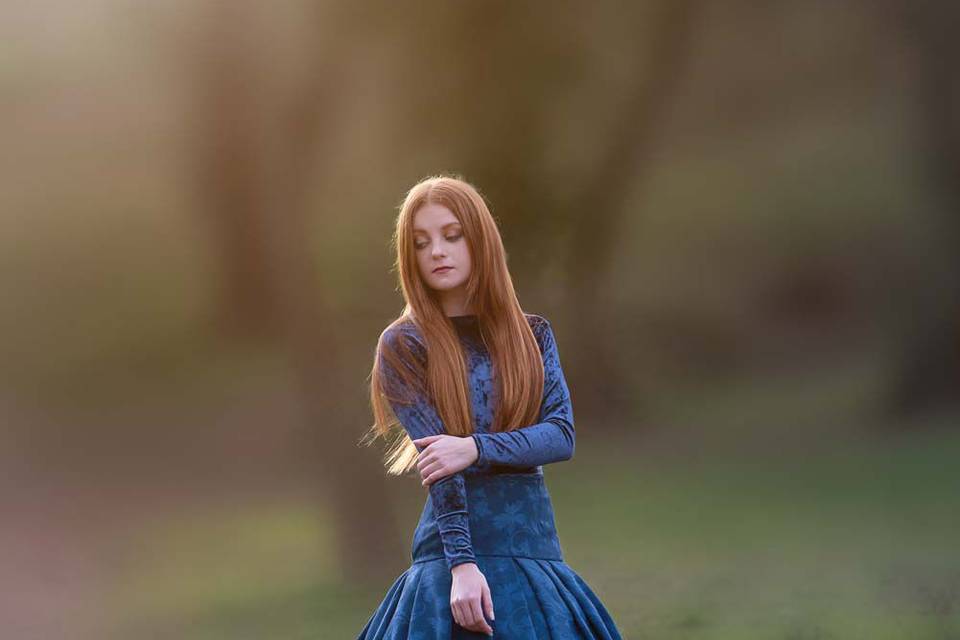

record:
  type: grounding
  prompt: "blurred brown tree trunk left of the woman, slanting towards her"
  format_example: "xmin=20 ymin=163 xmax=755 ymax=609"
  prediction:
xmin=193 ymin=2 xmax=402 ymax=581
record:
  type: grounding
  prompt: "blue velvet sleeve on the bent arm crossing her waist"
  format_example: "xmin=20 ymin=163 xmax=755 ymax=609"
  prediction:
xmin=471 ymin=316 xmax=575 ymax=467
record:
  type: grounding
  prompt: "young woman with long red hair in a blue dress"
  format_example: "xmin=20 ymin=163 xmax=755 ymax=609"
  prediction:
xmin=358 ymin=176 xmax=620 ymax=640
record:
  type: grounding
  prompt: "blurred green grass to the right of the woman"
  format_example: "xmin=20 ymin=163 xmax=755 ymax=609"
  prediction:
xmin=551 ymin=424 xmax=960 ymax=639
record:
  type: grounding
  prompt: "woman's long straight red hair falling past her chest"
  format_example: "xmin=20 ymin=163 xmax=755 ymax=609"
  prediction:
xmin=368 ymin=175 xmax=544 ymax=475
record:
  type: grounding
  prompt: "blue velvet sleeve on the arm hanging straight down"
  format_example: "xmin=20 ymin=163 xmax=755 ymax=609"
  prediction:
xmin=380 ymin=329 xmax=476 ymax=569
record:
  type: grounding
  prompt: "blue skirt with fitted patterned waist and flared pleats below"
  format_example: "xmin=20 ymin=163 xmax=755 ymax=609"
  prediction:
xmin=357 ymin=467 xmax=621 ymax=640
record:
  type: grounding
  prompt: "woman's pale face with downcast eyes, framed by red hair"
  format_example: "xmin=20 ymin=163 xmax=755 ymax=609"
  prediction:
xmin=413 ymin=204 xmax=471 ymax=294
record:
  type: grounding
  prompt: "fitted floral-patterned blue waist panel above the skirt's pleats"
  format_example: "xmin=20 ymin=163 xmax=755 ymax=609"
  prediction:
xmin=412 ymin=467 xmax=563 ymax=562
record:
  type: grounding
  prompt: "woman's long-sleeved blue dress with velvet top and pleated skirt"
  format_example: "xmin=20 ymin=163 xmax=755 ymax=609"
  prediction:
xmin=357 ymin=314 xmax=621 ymax=640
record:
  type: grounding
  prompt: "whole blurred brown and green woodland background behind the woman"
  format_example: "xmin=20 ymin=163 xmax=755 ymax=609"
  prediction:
xmin=0 ymin=0 xmax=960 ymax=640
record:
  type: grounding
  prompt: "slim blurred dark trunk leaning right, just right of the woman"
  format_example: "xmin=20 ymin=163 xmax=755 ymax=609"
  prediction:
xmin=565 ymin=0 xmax=699 ymax=424
